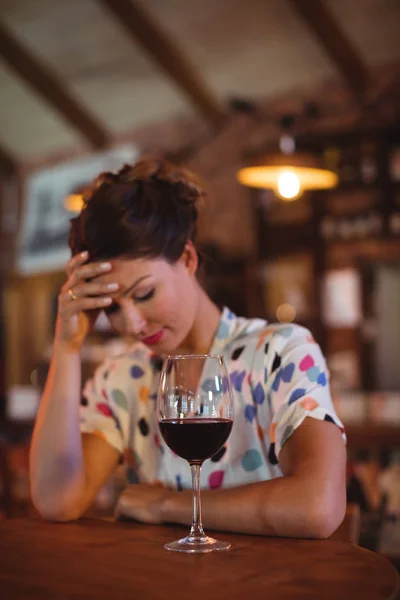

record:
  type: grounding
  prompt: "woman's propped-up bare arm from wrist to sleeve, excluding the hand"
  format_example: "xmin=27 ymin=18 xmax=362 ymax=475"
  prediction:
xmin=30 ymin=344 xmax=119 ymax=521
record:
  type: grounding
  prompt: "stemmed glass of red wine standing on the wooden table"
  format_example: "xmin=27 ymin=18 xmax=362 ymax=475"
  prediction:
xmin=158 ymin=354 xmax=233 ymax=552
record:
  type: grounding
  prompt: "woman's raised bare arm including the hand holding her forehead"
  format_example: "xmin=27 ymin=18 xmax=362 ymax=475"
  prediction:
xmin=30 ymin=256 xmax=118 ymax=520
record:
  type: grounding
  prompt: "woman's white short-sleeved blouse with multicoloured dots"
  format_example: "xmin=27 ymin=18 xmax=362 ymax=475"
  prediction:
xmin=81 ymin=309 xmax=342 ymax=490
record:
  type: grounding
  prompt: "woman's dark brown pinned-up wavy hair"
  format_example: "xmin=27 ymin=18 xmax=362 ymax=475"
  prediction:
xmin=69 ymin=158 xmax=205 ymax=262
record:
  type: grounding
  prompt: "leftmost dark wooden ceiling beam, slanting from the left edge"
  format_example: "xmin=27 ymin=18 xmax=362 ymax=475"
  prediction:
xmin=0 ymin=23 xmax=109 ymax=148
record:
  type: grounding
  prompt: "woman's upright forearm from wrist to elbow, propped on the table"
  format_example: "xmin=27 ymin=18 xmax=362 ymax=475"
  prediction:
xmin=30 ymin=345 xmax=85 ymax=518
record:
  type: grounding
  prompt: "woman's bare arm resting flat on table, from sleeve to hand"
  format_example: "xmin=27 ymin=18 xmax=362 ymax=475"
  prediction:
xmin=117 ymin=418 xmax=346 ymax=538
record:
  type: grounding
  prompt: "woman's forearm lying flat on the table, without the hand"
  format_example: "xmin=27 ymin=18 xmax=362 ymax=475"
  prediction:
xmin=161 ymin=476 xmax=344 ymax=538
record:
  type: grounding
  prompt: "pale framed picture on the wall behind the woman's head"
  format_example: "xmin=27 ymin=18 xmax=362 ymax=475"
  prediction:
xmin=16 ymin=144 xmax=139 ymax=274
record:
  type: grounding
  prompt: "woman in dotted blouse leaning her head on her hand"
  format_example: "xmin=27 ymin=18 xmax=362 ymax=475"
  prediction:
xmin=31 ymin=159 xmax=346 ymax=538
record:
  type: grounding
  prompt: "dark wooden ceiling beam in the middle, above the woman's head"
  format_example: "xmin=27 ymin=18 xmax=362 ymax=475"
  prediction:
xmin=98 ymin=0 xmax=225 ymax=126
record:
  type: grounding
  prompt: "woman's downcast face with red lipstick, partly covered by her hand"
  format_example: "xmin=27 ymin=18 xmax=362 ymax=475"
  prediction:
xmin=97 ymin=248 xmax=199 ymax=354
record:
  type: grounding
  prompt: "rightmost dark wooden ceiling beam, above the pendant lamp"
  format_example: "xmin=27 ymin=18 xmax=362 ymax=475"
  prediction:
xmin=287 ymin=0 xmax=368 ymax=102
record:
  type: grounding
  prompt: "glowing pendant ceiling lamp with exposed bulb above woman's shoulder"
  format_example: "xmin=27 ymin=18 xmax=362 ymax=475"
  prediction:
xmin=237 ymin=153 xmax=339 ymax=200
